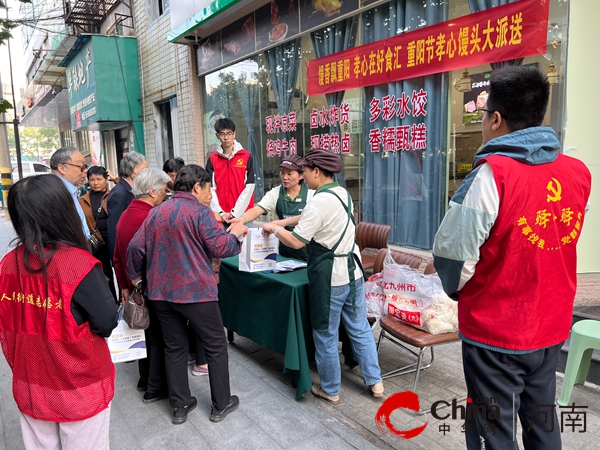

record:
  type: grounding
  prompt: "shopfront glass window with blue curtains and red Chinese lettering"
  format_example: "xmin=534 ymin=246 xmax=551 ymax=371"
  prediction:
xmin=198 ymin=0 xmax=568 ymax=249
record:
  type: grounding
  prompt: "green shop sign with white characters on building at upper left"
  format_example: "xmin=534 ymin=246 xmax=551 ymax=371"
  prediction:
xmin=66 ymin=45 xmax=98 ymax=130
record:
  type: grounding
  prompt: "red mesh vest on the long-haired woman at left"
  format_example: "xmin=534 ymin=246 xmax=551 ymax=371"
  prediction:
xmin=0 ymin=245 xmax=115 ymax=422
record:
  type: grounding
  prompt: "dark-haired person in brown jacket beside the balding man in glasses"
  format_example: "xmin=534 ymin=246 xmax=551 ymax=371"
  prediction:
xmin=79 ymin=166 xmax=117 ymax=302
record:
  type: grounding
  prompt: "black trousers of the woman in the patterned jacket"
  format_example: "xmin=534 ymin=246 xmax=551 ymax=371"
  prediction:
xmin=153 ymin=301 xmax=231 ymax=410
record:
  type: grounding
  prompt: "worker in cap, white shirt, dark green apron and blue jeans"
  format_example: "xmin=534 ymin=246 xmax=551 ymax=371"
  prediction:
xmin=263 ymin=149 xmax=383 ymax=405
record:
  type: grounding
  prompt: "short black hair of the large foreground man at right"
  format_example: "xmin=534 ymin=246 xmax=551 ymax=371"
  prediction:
xmin=486 ymin=66 xmax=550 ymax=132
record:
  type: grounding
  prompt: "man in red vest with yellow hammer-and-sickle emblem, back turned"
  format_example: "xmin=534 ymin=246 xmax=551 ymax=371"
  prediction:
xmin=433 ymin=66 xmax=591 ymax=450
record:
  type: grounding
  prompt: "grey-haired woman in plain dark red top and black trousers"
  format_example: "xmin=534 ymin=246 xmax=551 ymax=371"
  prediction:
xmin=113 ymin=168 xmax=169 ymax=396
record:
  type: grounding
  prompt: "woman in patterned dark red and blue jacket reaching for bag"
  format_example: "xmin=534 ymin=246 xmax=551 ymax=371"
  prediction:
xmin=127 ymin=164 xmax=248 ymax=425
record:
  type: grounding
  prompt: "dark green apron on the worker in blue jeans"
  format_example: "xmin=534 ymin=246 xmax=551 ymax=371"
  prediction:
xmin=307 ymin=183 xmax=365 ymax=331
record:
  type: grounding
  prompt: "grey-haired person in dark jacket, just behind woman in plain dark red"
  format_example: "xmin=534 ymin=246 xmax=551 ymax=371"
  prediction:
xmin=107 ymin=152 xmax=148 ymax=260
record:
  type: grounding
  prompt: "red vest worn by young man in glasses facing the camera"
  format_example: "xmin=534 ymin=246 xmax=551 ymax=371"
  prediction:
xmin=210 ymin=149 xmax=254 ymax=213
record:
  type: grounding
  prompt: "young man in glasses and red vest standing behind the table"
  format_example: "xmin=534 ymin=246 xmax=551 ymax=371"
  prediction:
xmin=206 ymin=118 xmax=254 ymax=220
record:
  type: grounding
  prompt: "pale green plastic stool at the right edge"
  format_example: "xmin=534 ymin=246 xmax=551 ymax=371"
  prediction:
xmin=556 ymin=320 xmax=600 ymax=406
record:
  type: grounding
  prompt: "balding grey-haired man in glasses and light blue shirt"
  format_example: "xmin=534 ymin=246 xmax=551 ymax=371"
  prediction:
xmin=50 ymin=147 xmax=90 ymax=239
